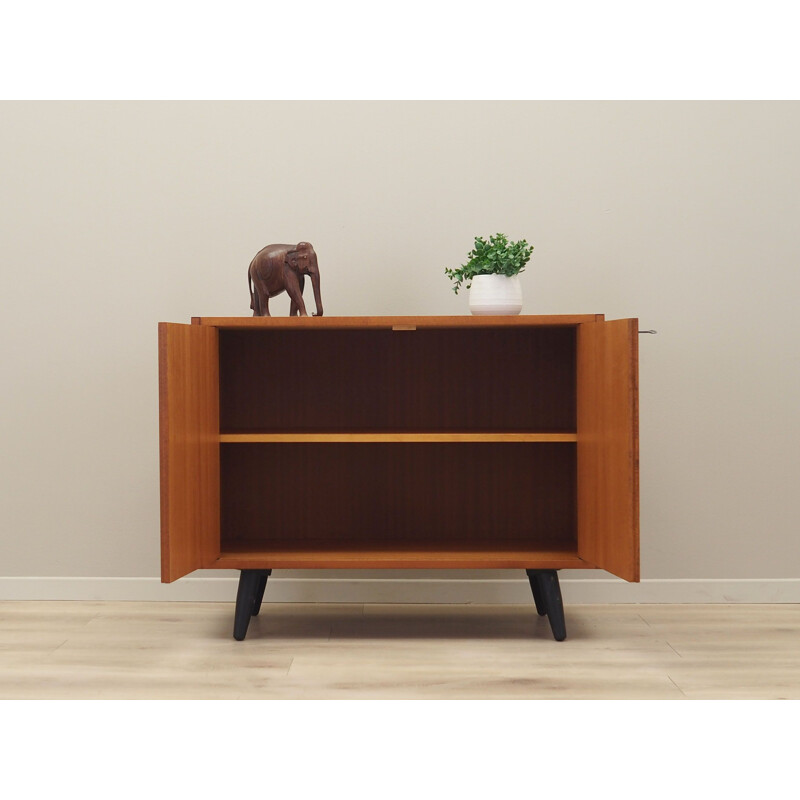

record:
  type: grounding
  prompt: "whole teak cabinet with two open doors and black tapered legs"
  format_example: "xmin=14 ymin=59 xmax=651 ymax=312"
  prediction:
xmin=158 ymin=314 xmax=639 ymax=639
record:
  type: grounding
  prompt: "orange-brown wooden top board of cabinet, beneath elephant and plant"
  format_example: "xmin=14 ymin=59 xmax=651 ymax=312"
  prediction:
xmin=192 ymin=314 xmax=604 ymax=330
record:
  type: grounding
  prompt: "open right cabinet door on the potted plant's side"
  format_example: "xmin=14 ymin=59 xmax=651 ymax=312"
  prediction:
xmin=577 ymin=319 xmax=639 ymax=581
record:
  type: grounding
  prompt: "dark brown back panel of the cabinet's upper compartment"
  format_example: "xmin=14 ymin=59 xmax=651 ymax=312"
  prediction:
xmin=219 ymin=326 xmax=576 ymax=433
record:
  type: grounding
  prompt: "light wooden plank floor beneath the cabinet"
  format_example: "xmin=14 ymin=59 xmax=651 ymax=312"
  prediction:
xmin=0 ymin=601 xmax=800 ymax=700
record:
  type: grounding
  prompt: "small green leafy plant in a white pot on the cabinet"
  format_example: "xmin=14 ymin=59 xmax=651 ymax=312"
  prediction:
xmin=445 ymin=233 xmax=533 ymax=314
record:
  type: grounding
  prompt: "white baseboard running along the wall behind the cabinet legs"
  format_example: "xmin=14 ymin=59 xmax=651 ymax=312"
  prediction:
xmin=0 ymin=575 xmax=800 ymax=605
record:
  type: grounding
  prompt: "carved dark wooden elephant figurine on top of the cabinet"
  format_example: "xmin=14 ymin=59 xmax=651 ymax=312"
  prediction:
xmin=247 ymin=242 xmax=322 ymax=317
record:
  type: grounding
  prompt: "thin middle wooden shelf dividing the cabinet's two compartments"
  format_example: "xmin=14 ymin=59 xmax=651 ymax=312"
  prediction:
xmin=219 ymin=432 xmax=578 ymax=444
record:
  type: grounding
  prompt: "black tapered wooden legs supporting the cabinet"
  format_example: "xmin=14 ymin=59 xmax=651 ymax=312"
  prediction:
xmin=233 ymin=569 xmax=567 ymax=642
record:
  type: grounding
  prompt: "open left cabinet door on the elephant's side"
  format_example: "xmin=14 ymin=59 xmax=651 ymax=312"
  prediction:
xmin=158 ymin=322 xmax=219 ymax=583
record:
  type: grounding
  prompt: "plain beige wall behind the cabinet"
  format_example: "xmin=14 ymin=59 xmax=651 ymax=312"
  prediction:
xmin=0 ymin=102 xmax=800 ymax=592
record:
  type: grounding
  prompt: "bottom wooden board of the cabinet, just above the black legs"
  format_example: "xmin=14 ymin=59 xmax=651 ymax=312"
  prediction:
xmin=213 ymin=544 xmax=594 ymax=569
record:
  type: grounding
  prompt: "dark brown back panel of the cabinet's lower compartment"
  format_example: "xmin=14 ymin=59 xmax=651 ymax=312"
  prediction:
xmin=220 ymin=443 xmax=577 ymax=550
